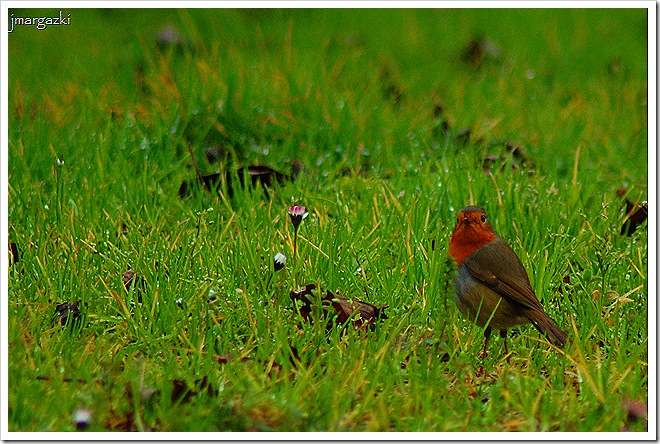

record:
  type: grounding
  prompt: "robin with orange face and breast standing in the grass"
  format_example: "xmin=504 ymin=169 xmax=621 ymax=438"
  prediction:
xmin=449 ymin=206 xmax=567 ymax=359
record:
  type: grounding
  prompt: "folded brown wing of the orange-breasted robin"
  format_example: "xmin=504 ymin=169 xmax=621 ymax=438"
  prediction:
xmin=463 ymin=237 xmax=543 ymax=311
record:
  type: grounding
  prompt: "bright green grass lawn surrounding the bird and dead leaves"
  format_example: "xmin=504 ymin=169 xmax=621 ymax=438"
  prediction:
xmin=7 ymin=9 xmax=648 ymax=431
